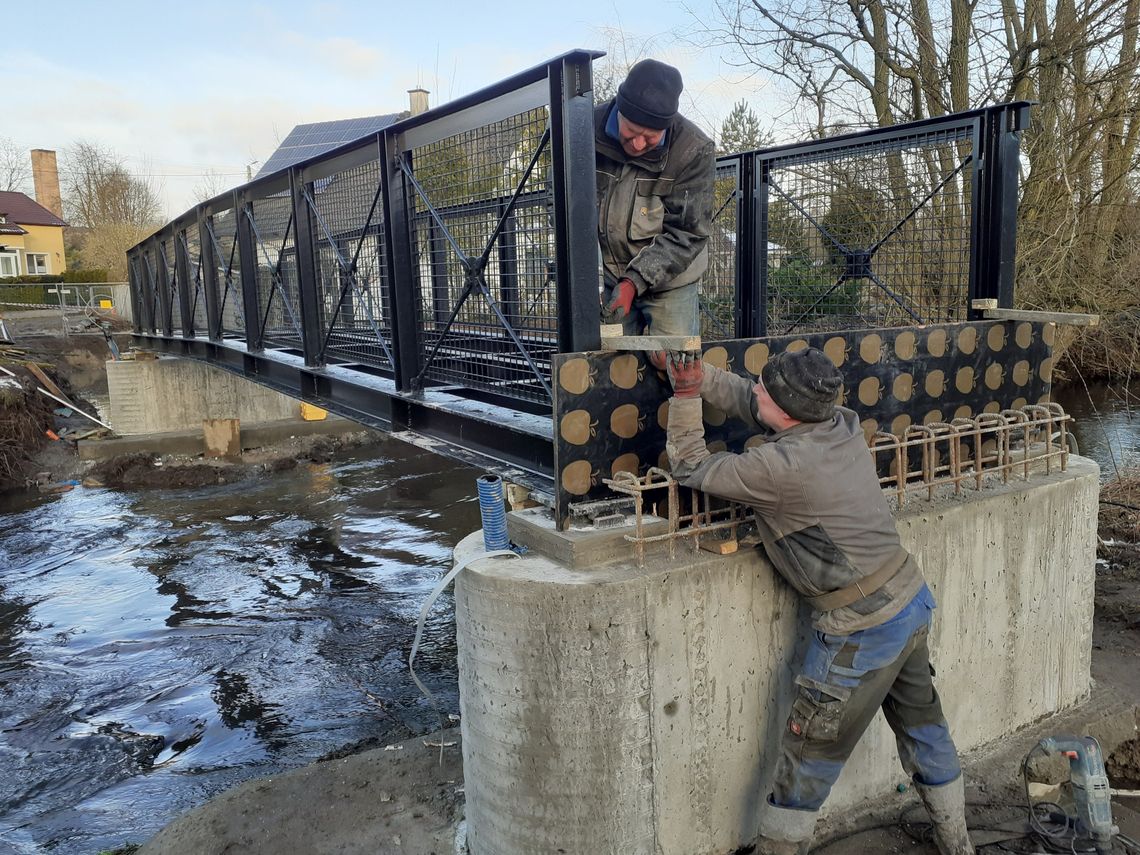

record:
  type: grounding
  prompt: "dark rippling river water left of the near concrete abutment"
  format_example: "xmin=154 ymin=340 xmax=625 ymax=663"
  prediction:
xmin=0 ymin=440 xmax=480 ymax=855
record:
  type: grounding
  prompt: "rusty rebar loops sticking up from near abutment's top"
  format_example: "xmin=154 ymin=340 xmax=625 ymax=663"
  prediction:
xmin=603 ymin=404 xmax=1073 ymax=567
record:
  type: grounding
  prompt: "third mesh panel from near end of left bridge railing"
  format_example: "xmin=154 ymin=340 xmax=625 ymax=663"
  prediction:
xmin=250 ymin=193 xmax=303 ymax=351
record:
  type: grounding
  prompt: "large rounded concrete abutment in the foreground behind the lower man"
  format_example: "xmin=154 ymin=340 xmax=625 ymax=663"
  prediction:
xmin=455 ymin=457 xmax=1099 ymax=855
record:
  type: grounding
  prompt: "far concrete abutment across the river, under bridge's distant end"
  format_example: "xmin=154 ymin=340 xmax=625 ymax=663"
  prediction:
xmin=107 ymin=357 xmax=301 ymax=435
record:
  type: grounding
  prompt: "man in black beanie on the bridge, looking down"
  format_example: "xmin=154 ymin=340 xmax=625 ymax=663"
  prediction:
xmin=594 ymin=59 xmax=716 ymax=335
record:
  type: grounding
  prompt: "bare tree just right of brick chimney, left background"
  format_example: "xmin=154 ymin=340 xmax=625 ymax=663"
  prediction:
xmin=62 ymin=140 xmax=162 ymax=278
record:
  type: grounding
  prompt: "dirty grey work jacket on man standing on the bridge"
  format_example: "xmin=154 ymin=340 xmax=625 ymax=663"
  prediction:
xmin=594 ymin=100 xmax=716 ymax=295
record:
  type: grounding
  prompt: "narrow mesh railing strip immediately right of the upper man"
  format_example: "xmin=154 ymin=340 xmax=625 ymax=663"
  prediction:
xmin=700 ymin=158 xmax=741 ymax=340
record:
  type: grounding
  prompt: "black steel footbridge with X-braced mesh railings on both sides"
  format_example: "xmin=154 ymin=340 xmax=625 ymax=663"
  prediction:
xmin=128 ymin=51 xmax=1027 ymax=513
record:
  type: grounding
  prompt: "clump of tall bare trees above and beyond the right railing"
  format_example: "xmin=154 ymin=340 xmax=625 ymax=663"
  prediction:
xmin=705 ymin=0 xmax=1140 ymax=323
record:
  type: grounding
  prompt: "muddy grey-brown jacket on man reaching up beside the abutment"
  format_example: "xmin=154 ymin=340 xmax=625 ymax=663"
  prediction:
xmin=667 ymin=365 xmax=923 ymax=635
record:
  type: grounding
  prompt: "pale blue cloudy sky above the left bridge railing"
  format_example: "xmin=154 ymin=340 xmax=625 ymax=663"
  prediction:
xmin=0 ymin=0 xmax=780 ymax=219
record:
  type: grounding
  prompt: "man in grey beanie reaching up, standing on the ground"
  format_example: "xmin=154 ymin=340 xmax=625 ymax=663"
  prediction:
xmin=652 ymin=348 xmax=974 ymax=855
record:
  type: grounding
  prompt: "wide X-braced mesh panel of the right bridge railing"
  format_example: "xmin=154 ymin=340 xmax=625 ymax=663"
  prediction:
xmin=759 ymin=123 xmax=977 ymax=335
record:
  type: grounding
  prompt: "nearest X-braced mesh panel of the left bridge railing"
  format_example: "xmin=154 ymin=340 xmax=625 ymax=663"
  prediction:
xmin=410 ymin=107 xmax=557 ymax=406
